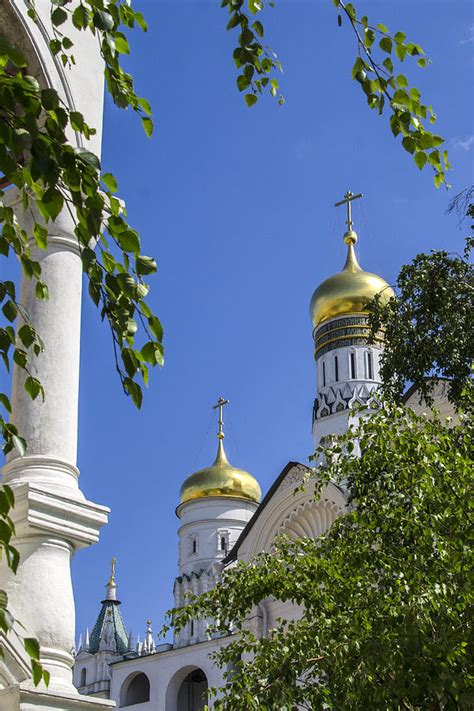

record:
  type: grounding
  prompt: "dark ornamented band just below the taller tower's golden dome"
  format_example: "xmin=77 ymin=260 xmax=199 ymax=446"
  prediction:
xmin=313 ymin=314 xmax=384 ymax=358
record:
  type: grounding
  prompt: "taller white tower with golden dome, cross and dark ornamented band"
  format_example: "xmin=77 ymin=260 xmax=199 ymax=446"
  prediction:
xmin=310 ymin=190 xmax=393 ymax=446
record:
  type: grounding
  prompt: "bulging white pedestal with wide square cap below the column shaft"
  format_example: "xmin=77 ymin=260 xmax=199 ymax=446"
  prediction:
xmin=0 ymin=483 xmax=109 ymax=696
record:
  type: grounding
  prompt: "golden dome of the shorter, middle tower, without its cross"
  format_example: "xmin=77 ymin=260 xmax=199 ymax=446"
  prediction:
xmin=180 ymin=435 xmax=262 ymax=504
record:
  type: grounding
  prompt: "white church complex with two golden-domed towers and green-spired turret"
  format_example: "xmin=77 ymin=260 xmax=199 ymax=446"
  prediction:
xmin=74 ymin=204 xmax=393 ymax=711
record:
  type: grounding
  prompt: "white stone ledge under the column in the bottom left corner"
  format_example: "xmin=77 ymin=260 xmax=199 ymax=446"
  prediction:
xmin=0 ymin=682 xmax=115 ymax=711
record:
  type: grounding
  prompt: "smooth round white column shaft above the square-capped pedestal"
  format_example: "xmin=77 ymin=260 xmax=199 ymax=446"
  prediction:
xmin=5 ymin=207 xmax=82 ymax=496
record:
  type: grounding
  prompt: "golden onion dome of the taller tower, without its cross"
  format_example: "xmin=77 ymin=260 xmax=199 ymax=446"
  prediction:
xmin=310 ymin=229 xmax=394 ymax=328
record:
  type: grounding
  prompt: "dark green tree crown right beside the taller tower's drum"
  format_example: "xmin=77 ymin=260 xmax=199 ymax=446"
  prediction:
xmin=370 ymin=238 xmax=474 ymax=401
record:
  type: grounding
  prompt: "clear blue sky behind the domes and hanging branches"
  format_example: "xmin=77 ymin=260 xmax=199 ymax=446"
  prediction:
xmin=68 ymin=0 xmax=474 ymax=635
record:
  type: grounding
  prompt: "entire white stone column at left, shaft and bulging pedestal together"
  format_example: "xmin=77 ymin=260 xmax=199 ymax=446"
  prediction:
xmin=0 ymin=203 xmax=109 ymax=708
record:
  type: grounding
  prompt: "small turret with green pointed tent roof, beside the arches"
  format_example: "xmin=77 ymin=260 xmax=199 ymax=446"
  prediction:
xmin=74 ymin=558 xmax=131 ymax=698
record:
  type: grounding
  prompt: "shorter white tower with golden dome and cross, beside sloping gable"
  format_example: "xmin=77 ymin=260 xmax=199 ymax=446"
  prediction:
xmin=174 ymin=397 xmax=261 ymax=647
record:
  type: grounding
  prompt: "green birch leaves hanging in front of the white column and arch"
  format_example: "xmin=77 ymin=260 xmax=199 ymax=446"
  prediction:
xmin=0 ymin=0 xmax=163 ymax=683
